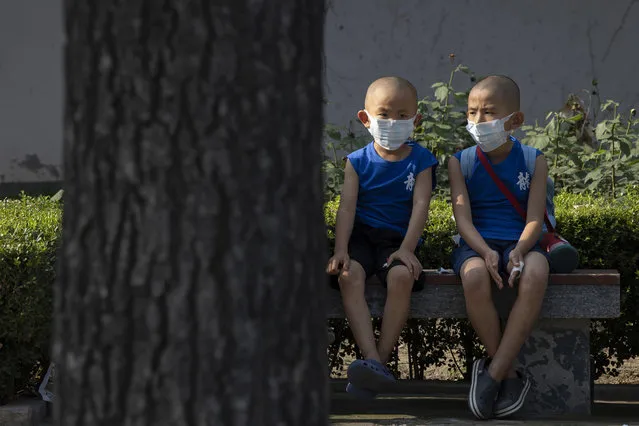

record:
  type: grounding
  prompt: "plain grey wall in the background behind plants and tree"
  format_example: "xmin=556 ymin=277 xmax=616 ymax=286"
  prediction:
xmin=0 ymin=0 xmax=639 ymax=182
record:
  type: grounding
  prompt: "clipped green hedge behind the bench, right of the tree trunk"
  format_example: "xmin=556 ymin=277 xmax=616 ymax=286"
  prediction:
xmin=325 ymin=188 xmax=639 ymax=378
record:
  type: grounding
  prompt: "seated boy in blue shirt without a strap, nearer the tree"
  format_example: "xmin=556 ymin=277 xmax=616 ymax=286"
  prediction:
xmin=326 ymin=77 xmax=438 ymax=398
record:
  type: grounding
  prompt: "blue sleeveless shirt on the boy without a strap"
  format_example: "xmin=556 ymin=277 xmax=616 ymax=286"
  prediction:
xmin=348 ymin=142 xmax=438 ymax=235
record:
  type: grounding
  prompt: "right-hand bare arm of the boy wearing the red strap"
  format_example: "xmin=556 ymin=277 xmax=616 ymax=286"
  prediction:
xmin=516 ymin=155 xmax=548 ymax=255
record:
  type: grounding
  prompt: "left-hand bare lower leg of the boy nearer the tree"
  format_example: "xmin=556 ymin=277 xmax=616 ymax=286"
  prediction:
xmin=339 ymin=259 xmax=380 ymax=361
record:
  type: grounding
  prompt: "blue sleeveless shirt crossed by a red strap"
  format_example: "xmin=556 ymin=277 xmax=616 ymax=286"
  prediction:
xmin=455 ymin=138 xmax=542 ymax=241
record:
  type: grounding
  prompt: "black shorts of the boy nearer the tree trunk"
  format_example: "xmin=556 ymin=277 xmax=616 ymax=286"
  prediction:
xmin=331 ymin=223 xmax=424 ymax=291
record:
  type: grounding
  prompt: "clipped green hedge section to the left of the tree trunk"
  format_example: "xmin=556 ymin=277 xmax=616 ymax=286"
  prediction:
xmin=0 ymin=197 xmax=61 ymax=403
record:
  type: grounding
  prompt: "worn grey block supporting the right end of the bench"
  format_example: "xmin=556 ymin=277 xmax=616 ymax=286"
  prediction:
xmin=519 ymin=319 xmax=591 ymax=417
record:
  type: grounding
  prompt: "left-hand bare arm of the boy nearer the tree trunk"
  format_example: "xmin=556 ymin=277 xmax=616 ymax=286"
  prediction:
xmin=335 ymin=160 xmax=359 ymax=253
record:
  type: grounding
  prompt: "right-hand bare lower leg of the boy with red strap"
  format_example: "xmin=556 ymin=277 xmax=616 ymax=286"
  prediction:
xmin=489 ymin=250 xmax=549 ymax=380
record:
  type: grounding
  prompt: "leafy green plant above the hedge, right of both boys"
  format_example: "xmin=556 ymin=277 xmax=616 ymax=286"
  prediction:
xmin=523 ymin=82 xmax=639 ymax=198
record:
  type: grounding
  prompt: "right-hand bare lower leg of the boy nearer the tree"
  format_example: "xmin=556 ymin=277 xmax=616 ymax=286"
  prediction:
xmin=377 ymin=261 xmax=415 ymax=364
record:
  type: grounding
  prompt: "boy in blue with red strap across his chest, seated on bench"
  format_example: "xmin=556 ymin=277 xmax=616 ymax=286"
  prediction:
xmin=448 ymin=75 xmax=549 ymax=419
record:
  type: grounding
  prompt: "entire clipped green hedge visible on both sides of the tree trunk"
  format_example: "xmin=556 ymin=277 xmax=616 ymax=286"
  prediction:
xmin=0 ymin=189 xmax=639 ymax=403
